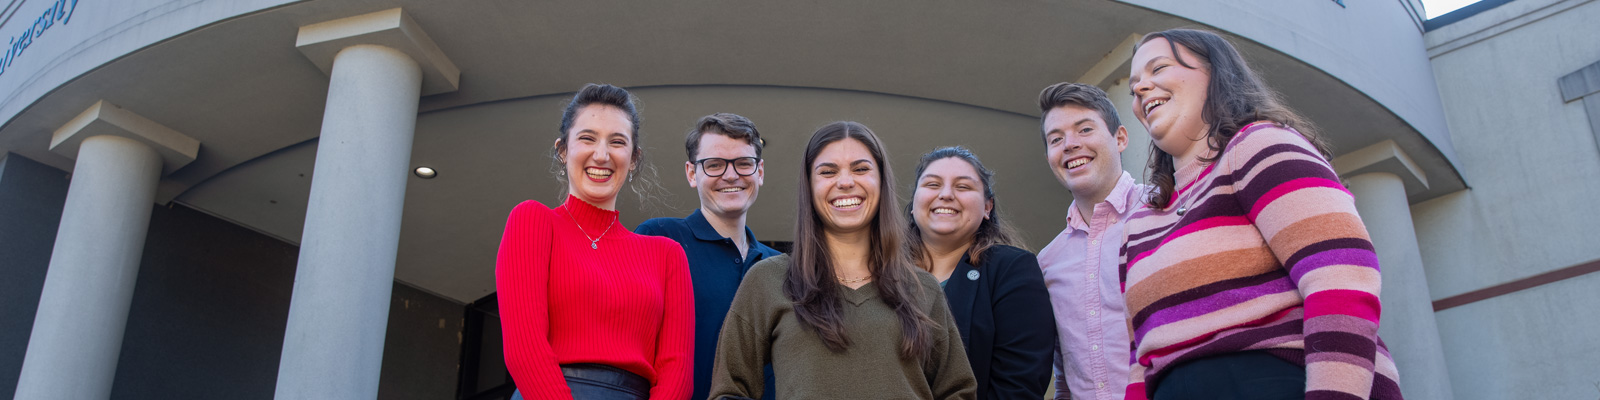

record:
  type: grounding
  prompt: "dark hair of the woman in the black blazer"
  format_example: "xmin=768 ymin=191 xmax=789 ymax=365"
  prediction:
xmin=906 ymin=146 xmax=1022 ymax=272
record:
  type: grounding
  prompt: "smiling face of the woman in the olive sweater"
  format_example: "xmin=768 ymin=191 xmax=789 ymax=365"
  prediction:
xmin=810 ymin=138 xmax=882 ymax=234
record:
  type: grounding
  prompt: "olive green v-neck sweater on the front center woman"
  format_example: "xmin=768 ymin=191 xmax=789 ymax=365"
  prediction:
xmin=709 ymin=254 xmax=978 ymax=400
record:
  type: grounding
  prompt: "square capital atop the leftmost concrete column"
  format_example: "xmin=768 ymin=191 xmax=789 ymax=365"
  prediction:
xmin=50 ymin=101 xmax=200 ymax=176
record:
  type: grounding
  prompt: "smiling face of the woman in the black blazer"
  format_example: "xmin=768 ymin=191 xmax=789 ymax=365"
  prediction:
xmin=910 ymin=157 xmax=994 ymax=243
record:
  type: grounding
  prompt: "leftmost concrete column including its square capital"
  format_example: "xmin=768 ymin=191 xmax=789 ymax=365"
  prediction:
xmin=16 ymin=102 xmax=200 ymax=400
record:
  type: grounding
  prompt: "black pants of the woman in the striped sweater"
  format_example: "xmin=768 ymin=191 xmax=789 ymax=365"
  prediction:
xmin=1154 ymin=352 xmax=1306 ymax=400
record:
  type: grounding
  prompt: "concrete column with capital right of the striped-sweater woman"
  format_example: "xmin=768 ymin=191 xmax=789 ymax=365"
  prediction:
xmin=1334 ymin=141 xmax=1454 ymax=398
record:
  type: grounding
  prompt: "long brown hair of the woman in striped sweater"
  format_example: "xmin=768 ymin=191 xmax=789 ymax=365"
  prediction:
xmin=1134 ymin=29 xmax=1333 ymax=208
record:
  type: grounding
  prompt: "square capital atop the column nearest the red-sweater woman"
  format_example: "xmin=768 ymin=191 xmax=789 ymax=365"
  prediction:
xmin=294 ymin=8 xmax=461 ymax=96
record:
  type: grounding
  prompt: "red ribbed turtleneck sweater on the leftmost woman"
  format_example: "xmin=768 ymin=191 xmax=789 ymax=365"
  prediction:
xmin=494 ymin=195 xmax=694 ymax=400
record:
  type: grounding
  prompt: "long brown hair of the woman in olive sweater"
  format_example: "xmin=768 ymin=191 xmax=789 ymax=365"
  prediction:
xmin=784 ymin=122 xmax=939 ymax=362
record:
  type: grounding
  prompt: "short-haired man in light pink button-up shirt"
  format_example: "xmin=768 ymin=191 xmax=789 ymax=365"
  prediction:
xmin=1038 ymin=83 xmax=1149 ymax=400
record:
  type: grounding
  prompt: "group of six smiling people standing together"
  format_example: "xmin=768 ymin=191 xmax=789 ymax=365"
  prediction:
xmin=496 ymin=29 xmax=1400 ymax=400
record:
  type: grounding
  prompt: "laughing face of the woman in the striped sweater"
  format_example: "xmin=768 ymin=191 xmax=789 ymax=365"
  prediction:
xmin=1128 ymin=37 xmax=1211 ymax=160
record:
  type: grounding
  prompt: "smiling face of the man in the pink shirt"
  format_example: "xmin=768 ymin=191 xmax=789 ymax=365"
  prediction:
xmin=1043 ymin=104 xmax=1128 ymax=203
